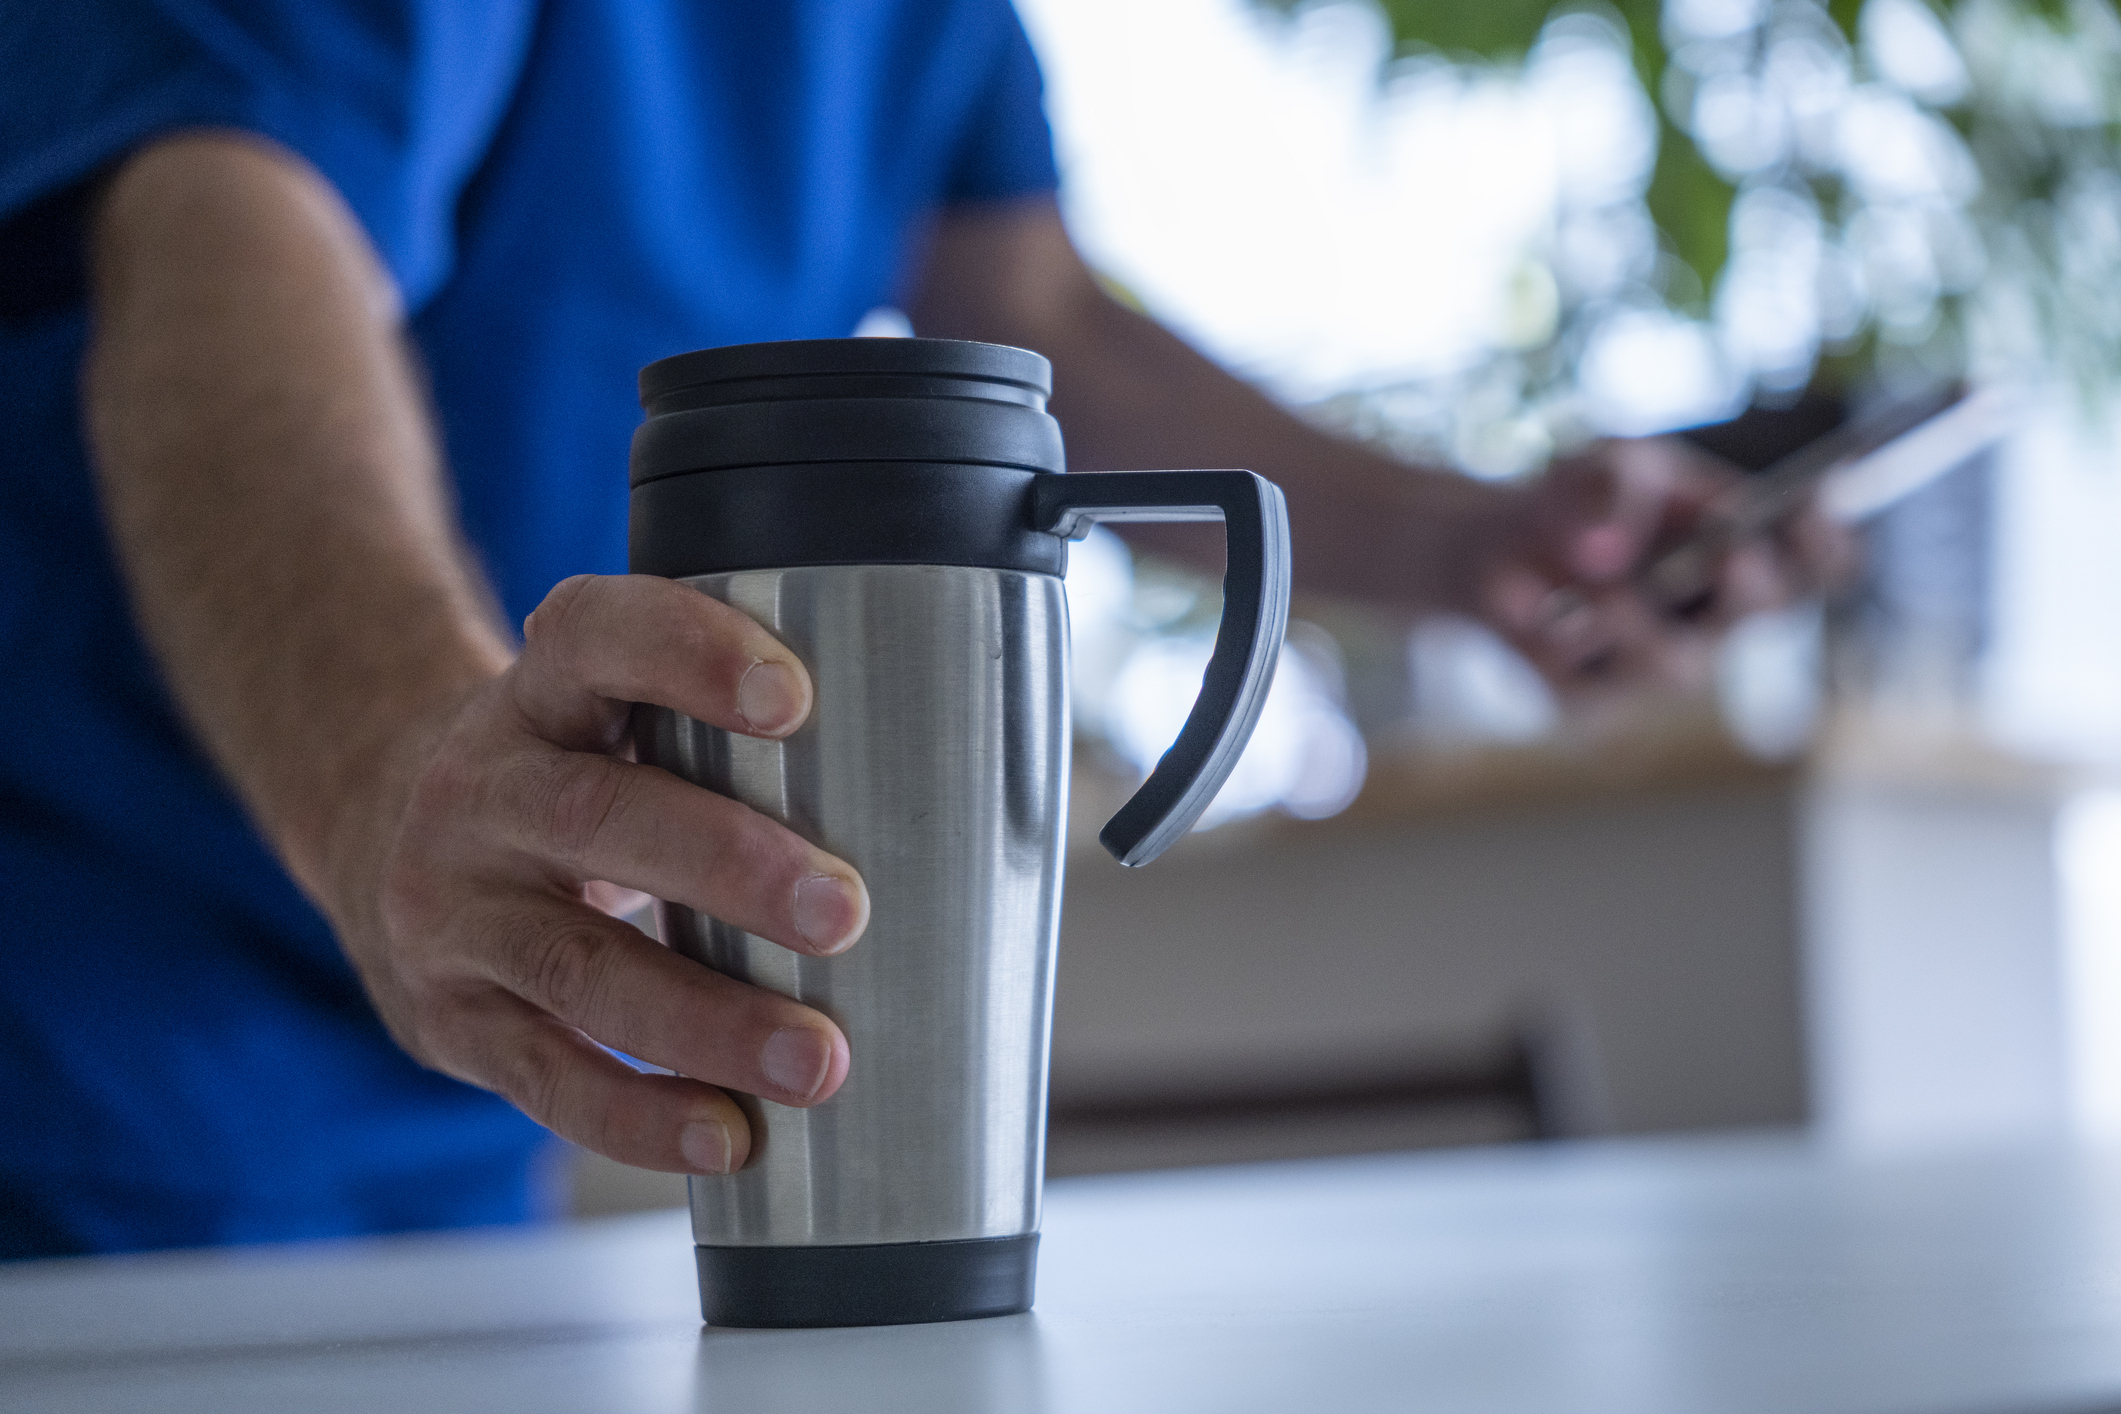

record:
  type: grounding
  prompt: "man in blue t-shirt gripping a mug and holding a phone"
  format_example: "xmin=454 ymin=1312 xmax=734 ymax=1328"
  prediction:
xmin=0 ymin=0 xmax=1824 ymax=1257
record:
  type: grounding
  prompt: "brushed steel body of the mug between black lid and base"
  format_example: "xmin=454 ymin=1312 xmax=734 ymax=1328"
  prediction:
xmin=638 ymin=566 xmax=1069 ymax=1244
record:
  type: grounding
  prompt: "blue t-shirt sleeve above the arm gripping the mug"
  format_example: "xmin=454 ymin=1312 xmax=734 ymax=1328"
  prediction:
xmin=0 ymin=0 xmax=534 ymax=307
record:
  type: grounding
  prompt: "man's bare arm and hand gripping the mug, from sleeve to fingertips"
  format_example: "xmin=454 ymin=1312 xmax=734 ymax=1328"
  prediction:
xmin=85 ymin=134 xmax=867 ymax=1172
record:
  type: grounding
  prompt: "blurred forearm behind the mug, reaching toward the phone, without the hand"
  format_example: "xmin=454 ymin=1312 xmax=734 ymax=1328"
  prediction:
xmin=912 ymin=204 xmax=1512 ymax=608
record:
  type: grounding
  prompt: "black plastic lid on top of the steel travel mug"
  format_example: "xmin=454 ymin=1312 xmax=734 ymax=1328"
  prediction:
xmin=630 ymin=339 xmax=1067 ymax=577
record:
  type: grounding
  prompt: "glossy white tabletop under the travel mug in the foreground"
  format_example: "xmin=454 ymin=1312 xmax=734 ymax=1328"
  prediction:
xmin=0 ymin=1138 xmax=2121 ymax=1414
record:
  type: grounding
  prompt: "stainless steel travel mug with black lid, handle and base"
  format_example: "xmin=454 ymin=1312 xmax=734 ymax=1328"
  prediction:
xmin=632 ymin=339 xmax=1290 ymax=1327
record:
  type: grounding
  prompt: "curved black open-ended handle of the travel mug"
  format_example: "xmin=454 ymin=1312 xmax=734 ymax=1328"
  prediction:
xmin=1031 ymin=471 xmax=1290 ymax=867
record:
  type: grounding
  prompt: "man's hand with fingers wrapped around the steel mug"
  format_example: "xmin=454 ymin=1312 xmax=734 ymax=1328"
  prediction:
xmin=360 ymin=577 xmax=867 ymax=1172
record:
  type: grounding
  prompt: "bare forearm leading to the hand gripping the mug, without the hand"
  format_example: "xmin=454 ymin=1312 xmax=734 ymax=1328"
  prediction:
xmin=83 ymin=134 xmax=511 ymax=907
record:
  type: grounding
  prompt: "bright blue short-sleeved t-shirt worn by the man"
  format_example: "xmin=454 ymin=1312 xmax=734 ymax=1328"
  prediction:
xmin=0 ymin=0 xmax=1054 ymax=1255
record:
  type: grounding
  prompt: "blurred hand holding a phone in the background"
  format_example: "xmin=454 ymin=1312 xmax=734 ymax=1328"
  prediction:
xmin=1470 ymin=437 xmax=1854 ymax=695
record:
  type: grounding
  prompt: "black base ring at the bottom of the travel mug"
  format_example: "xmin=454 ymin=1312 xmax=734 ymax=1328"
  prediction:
xmin=694 ymin=1232 xmax=1039 ymax=1327
